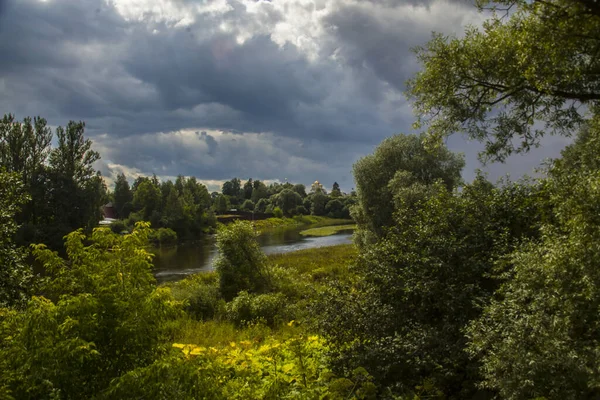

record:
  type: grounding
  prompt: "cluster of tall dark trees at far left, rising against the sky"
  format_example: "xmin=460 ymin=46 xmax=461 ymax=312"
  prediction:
xmin=0 ymin=114 xmax=108 ymax=248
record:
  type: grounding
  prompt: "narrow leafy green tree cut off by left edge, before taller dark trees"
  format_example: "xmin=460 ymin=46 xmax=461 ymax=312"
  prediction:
xmin=0 ymin=171 xmax=32 ymax=307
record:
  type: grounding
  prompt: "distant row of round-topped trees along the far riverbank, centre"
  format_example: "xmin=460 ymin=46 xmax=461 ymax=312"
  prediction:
xmin=212 ymin=178 xmax=356 ymax=218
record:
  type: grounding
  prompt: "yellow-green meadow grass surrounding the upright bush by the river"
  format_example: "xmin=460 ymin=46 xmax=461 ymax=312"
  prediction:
xmin=166 ymin=244 xmax=358 ymax=348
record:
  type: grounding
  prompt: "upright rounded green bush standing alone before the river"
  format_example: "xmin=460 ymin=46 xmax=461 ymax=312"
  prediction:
xmin=214 ymin=221 xmax=270 ymax=300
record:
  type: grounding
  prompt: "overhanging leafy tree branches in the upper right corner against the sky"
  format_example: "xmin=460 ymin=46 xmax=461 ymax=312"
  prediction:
xmin=408 ymin=0 xmax=600 ymax=160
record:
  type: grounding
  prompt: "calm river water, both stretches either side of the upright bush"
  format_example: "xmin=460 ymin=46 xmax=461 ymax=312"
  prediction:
xmin=153 ymin=227 xmax=352 ymax=282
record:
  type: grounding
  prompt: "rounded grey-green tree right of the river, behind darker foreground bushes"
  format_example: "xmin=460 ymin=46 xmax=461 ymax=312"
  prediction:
xmin=354 ymin=135 xmax=464 ymax=244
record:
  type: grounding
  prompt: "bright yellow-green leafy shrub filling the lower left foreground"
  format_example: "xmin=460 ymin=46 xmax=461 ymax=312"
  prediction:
xmin=0 ymin=223 xmax=180 ymax=399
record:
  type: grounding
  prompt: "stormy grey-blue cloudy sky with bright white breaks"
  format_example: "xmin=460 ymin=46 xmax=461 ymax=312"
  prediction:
xmin=0 ymin=0 xmax=567 ymax=191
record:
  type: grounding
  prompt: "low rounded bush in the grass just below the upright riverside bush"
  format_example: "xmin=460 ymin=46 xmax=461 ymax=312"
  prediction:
xmin=227 ymin=291 xmax=286 ymax=327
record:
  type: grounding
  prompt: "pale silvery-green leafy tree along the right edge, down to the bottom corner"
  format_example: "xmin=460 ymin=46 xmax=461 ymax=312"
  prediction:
xmin=467 ymin=116 xmax=600 ymax=399
